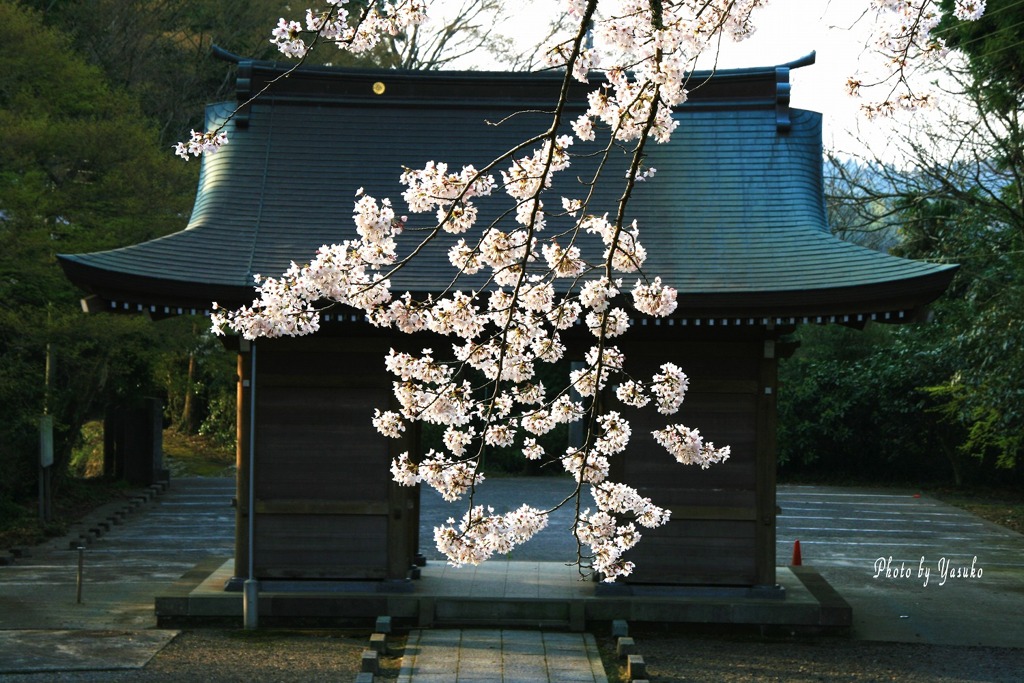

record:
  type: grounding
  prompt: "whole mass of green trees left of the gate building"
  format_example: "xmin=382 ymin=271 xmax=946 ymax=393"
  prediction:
xmin=0 ymin=0 xmax=407 ymax=501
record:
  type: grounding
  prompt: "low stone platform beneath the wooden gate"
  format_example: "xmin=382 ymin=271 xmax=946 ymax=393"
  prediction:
xmin=156 ymin=559 xmax=852 ymax=631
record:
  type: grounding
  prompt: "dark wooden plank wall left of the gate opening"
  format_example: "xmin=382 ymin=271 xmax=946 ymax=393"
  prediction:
xmin=240 ymin=336 xmax=419 ymax=580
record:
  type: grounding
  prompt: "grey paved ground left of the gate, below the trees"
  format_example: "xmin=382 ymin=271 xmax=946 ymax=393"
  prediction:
xmin=0 ymin=478 xmax=234 ymax=678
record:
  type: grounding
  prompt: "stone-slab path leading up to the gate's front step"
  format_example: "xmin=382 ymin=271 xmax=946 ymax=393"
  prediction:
xmin=398 ymin=629 xmax=608 ymax=683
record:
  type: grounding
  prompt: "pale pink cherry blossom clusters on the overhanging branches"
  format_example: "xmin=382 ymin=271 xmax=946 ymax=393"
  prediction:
xmin=205 ymin=0 xmax=984 ymax=581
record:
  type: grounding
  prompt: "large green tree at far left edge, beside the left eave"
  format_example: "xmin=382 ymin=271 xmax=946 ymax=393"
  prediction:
xmin=0 ymin=0 xmax=195 ymax=500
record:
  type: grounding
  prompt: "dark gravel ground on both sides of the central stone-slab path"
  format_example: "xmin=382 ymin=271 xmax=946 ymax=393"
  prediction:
xmin=0 ymin=629 xmax=1024 ymax=683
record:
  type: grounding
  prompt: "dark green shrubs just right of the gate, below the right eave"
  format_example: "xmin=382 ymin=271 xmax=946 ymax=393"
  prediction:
xmin=778 ymin=326 xmax=962 ymax=481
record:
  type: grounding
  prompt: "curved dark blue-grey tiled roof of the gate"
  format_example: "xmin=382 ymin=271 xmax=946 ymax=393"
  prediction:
xmin=60 ymin=56 xmax=953 ymax=319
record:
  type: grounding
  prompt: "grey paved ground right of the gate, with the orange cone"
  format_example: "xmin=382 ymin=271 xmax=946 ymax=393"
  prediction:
xmin=775 ymin=485 xmax=1024 ymax=647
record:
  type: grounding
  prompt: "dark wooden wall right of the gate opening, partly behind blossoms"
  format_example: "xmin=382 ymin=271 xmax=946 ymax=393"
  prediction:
xmin=611 ymin=328 xmax=776 ymax=586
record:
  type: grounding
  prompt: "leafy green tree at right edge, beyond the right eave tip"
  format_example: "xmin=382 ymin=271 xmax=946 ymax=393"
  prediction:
xmin=900 ymin=189 xmax=1024 ymax=468
